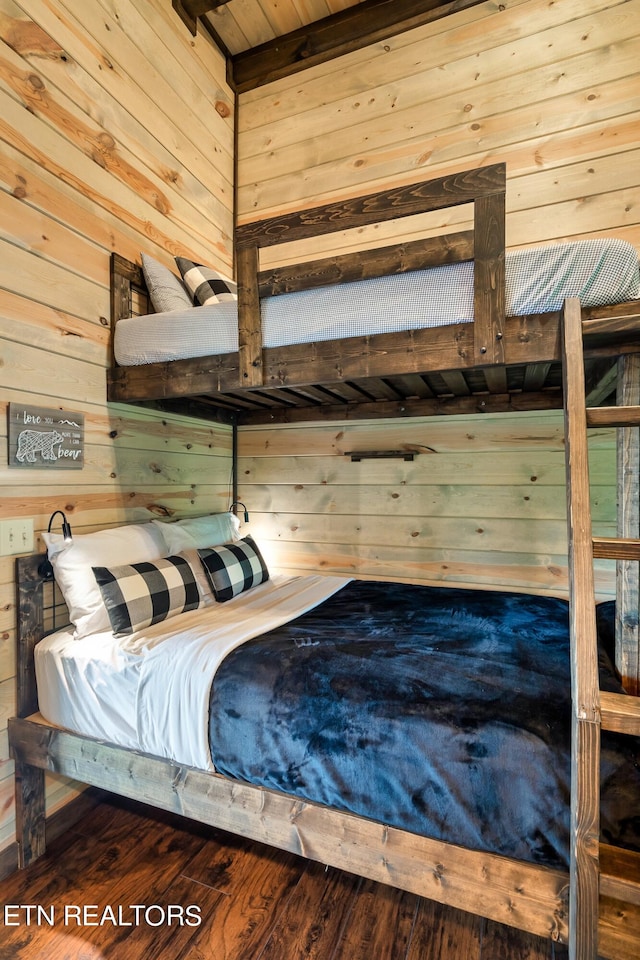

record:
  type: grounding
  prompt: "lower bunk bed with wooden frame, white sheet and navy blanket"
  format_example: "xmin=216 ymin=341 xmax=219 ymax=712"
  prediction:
xmin=9 ymin=540 xmax=640 ymax=960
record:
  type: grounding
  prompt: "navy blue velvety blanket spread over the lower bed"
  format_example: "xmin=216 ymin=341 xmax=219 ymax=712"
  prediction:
xmin=210 ymin=582 xmax=640 ymax=867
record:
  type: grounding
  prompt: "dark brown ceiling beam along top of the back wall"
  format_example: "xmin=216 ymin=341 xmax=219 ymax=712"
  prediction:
xmin=232 ymin=0 xmax=484 ymax=92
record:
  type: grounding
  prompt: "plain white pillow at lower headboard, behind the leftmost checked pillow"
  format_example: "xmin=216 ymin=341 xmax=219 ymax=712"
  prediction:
xmin=42 ymin=523 xmax=167 ymax=639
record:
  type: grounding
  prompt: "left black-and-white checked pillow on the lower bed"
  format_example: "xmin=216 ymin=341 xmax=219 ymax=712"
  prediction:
xmin=92 ymin=554 xmax=203 ymax=636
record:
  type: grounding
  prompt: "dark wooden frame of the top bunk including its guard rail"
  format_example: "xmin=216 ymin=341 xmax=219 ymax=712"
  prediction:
xmin=107 ymin=164 xmax=639 ymax=424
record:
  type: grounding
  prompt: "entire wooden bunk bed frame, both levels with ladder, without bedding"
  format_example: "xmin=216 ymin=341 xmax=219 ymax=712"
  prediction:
xmin=9 ymin=165 xmax=640 ymax=960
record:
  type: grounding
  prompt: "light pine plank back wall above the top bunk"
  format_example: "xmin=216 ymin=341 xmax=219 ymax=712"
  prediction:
xmin=238 ymin=0 xmax=640 ymax=259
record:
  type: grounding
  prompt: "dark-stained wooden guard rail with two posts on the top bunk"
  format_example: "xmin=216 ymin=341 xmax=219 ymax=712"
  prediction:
xmin=236 ymin=163 xmax=506 ymax=387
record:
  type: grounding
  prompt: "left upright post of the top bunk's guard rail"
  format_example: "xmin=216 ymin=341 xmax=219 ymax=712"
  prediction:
xmin=237 ymin=244 xmax=263 ymax=387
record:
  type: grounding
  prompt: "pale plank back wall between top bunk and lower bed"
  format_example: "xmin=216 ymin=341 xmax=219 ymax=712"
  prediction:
xmin=239 ymin=413 xmax=615 ymax=597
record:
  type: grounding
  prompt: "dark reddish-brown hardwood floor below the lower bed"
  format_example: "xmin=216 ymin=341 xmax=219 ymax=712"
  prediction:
xmin=0 ymin=800 xmax=568 ymax=960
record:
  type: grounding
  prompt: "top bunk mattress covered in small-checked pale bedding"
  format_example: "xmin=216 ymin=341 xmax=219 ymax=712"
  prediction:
xmin=114 ymin=239 xmax=640 ymax=366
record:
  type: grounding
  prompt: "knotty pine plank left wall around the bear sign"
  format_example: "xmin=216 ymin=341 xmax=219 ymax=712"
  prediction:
xmin=0 ymin=0 xmax=234 ymax=864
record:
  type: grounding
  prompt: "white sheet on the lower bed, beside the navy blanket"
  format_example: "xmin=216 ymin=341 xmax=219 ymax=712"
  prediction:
xmin=35 ymin=575 xmax=348 ymax=770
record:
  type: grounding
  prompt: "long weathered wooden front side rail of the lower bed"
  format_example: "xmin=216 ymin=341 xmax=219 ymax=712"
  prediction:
xmin=9 ymin=720 xmax=567 ymax=941
